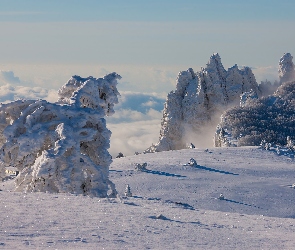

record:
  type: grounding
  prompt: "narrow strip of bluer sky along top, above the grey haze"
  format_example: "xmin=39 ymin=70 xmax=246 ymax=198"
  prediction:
xmin=0 ymin=0 xmax=294 ymax=22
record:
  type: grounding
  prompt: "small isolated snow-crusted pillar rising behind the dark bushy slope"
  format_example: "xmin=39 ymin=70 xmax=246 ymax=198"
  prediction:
xmin=278 ymin=53 xmax=295 ymax=84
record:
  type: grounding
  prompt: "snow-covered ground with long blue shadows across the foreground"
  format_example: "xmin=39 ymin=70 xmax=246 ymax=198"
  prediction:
xmin=0 ymin=147 xmax=295 ymax=249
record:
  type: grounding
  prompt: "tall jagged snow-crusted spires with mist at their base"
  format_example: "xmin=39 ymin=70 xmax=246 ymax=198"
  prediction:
xmin=145 ymin=54 xmax=260 ymax=152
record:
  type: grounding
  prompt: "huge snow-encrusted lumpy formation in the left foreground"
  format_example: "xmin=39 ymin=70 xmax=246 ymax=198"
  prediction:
xmin=0 ymin=73 xmax=121 ymax=197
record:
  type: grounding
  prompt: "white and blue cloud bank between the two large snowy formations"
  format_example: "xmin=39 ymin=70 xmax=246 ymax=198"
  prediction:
xmin=107 ymin=92 xmax=165 ymax=157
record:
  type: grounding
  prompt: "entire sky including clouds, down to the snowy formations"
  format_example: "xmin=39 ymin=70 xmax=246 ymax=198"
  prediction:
xmin=0 ymin=0 xmax=295 ymax=153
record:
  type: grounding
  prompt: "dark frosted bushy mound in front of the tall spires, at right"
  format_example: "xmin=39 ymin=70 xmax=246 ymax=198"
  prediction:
xmin=215 ymin=82 xmax=295 ymax=146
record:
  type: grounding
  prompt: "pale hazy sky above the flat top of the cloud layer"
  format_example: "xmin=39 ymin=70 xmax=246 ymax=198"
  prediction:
xmin=0 ymin=0 xmax=295 ymax=70
